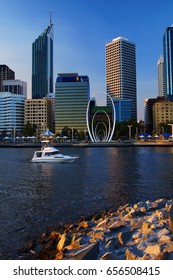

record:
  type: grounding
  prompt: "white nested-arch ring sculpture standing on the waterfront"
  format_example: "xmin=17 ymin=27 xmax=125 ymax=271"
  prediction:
xmin=86 ymin=93 xmax=116 ymax=142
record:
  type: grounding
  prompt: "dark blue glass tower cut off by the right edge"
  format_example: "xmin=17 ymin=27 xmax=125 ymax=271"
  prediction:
xmin=163 ymin=26 xmax=173 ymax=101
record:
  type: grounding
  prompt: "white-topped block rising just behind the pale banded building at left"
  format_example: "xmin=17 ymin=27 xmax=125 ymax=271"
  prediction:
xmin=3 ymin=80 xmax=27 ymax=98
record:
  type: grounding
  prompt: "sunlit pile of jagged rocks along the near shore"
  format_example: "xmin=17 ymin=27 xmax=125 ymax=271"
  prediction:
xmin=19 ymin=199 xmax=173 ymax=260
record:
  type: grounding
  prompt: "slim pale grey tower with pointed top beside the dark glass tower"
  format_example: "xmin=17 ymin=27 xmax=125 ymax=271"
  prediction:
xmin=157 ymin=55 xmax=165 ymax=96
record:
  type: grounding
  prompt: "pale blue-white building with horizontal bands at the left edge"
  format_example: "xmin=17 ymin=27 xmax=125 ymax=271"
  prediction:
xmin=0 ymin=92 xmax=25 ymax=136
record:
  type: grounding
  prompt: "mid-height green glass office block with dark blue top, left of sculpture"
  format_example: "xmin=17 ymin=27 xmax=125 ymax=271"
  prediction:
xmin=55 ymin=73 xmax=90 ymax=132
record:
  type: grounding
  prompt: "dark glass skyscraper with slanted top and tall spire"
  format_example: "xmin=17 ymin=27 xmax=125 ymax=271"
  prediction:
xmin=32 ymin=16 xmax=53 ymax=98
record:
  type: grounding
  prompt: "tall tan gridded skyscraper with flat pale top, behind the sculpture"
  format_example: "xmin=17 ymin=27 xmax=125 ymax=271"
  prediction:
xmin=106 ymin=37 xmax=137 ymax=120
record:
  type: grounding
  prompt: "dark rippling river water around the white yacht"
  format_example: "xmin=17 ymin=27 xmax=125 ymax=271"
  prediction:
xmin=0 ymin=147 xmax=173 ymax=259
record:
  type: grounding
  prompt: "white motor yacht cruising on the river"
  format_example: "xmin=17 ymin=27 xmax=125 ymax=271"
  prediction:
xmin=31 ymin=140 xmax=78 ymax=163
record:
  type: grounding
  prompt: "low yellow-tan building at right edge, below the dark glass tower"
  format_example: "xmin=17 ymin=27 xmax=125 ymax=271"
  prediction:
xmin=153 ymin=101 xmax=173 ymax=132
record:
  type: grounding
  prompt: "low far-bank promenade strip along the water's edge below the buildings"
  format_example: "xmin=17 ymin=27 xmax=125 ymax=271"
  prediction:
xmin=0 ymin=141 xmax=173 ymax=148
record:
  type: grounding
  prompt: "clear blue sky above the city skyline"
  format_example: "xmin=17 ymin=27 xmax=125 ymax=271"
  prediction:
xmin=0 ymin=0 xmax=173 ymax=119
